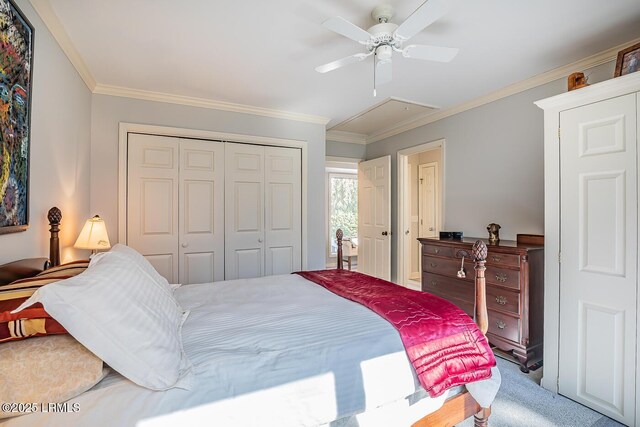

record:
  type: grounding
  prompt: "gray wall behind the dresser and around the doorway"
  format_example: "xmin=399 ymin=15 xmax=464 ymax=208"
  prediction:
xmin=366 ymin=63 xmax=614 ymax=280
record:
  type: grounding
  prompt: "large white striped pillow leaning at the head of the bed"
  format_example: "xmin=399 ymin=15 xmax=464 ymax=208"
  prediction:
xmin=15 ymin=253 xmax=191 ymax=390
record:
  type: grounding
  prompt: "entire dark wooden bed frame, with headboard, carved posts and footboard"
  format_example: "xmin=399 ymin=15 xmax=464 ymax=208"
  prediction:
xmin=0 ymin=212 xmax=491 ymax=427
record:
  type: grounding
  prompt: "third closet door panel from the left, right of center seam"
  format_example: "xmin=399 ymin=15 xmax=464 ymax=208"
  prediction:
xmin=225 ymin=143 xmax=265 ymax=280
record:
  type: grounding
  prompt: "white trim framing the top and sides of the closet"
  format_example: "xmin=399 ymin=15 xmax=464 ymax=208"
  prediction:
xmin=118 ymin=122 xmax=308 ymax=270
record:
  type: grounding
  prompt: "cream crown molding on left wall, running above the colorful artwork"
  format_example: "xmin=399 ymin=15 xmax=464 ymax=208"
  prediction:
xmin=30 ymin=0 xmax=96 ymax=92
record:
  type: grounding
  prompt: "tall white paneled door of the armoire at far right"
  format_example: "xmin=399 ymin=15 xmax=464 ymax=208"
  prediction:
xmin=558 ymin=94 xmax=638 ymax=425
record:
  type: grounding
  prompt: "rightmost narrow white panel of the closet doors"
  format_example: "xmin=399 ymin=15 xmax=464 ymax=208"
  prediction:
xmin=264 ymin=147 xmax=302 ymax=276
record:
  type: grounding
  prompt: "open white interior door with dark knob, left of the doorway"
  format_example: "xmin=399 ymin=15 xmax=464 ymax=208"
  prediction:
xmin=358 ymin=156 xmax=391 ymax=280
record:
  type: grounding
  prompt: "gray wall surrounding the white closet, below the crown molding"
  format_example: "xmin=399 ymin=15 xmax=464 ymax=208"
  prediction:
xmin=90 ymin=95 xmax=325 ymax=269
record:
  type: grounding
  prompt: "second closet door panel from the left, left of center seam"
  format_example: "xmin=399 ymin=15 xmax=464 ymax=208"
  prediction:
xmin=178 ymin=139 xmax=224 ymax=284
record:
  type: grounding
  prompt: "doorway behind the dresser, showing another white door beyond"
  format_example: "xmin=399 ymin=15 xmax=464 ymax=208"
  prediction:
xmin=397 ymin=140 xmax=444 ymax=290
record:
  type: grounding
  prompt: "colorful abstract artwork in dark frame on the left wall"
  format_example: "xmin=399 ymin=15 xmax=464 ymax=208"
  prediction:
xmin=0 ymin=0 xmax=33 ymax=233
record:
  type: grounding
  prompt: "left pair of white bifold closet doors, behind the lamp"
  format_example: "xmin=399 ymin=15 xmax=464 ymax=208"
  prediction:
xmin=127 ymin=134 xmax=224 ymax=284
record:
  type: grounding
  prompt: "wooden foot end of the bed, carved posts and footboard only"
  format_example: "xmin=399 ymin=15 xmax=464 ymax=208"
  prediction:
xmin=336 ymin=229 xmax=491 ymax=427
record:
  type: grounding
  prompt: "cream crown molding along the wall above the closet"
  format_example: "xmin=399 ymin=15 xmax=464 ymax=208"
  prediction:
xmin=93 ymin=83 xmax=329 ymax=126
